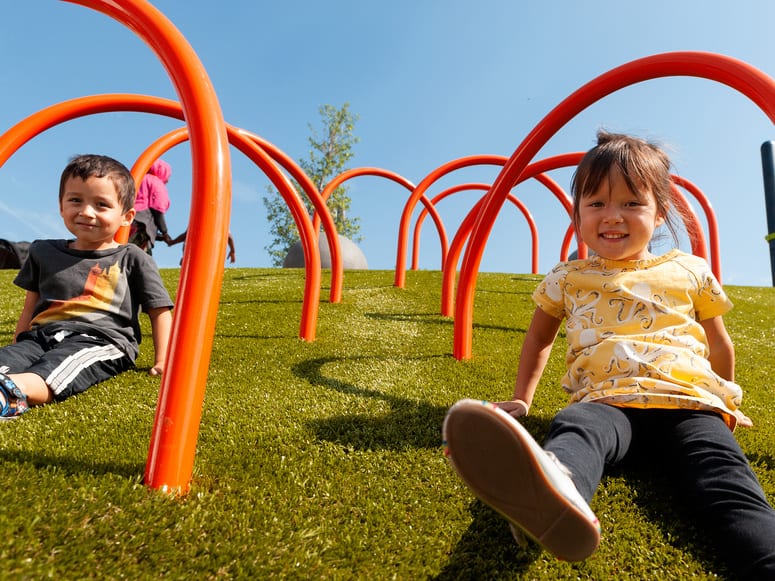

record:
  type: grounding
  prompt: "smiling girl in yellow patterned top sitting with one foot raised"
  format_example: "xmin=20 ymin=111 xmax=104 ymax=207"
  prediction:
xmin=443 ymin=132 xmax=775 ymax=579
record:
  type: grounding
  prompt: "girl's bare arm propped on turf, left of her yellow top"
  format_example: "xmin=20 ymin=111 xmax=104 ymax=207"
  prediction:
xmin=498 ymin=307 xmax=562 ymax=417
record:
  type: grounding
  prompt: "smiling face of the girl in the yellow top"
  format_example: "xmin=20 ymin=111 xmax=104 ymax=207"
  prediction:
xmin=577 ymin=169 xmax=665 ymax=260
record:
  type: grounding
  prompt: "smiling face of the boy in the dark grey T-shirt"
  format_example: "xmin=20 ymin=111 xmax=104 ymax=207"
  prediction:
xmin=59 ymin=177 xmax=135 ymax=250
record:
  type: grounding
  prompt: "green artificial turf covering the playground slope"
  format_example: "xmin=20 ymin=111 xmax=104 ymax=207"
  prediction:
xmin=0 ymin=269 xmax=775 ymax=580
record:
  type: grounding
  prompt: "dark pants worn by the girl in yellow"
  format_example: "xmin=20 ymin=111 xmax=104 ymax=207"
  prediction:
xmin=544 ymin=403 xmax=775 ymax=580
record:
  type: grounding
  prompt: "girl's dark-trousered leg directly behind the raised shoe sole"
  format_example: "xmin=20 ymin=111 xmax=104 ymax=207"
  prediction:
xmin=543 ymin=402 xmax=632 ymax=502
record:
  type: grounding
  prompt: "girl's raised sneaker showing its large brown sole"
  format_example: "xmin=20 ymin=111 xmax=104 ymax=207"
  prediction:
xmin=443 ymin=399 xmax=600 ymax=561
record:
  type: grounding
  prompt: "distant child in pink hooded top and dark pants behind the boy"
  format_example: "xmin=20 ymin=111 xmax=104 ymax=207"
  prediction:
xmin=129 ymin=159 xmax=172 ymax=254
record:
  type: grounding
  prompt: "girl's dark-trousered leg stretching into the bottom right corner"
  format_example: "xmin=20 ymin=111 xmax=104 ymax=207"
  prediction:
xmin=672 ymin=412 xmax=775 ymax=579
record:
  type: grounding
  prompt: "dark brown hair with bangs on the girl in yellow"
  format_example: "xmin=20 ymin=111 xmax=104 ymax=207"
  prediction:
xmin=571 ymin=130 xmax=684 ymax=244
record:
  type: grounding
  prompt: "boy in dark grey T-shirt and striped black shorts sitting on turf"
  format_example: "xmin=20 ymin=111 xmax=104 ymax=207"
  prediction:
xmin=0 ymin=155 xmax=172 ymax=419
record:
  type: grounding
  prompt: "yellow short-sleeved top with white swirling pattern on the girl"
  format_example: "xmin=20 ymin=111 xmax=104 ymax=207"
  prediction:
xmin=533 ymin=250 xmax=742 ymax=429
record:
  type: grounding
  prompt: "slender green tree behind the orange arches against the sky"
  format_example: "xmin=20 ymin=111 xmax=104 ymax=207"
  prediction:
xmin=263 ymin=103 xmax=362 ymax=266
